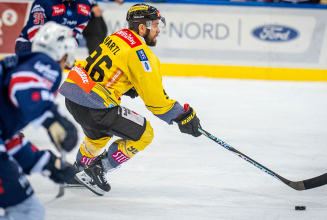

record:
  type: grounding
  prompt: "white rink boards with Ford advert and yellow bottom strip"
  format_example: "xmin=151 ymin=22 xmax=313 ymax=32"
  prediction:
xmin=0 ymin=1 xmax=327 ymax=81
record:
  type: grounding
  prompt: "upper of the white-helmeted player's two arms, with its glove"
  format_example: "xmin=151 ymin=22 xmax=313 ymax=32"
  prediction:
xmin=8 ymin=62 xmax=77 ymax=151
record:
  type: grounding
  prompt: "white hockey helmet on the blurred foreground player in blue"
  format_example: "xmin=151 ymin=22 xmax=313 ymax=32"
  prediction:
xmin=32 ymin=21 xmax=77 ymax=67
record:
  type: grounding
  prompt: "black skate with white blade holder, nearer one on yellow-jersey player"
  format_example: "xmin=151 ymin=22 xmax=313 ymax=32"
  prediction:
xmin=75 ymin=151 xmax=111 ymax=196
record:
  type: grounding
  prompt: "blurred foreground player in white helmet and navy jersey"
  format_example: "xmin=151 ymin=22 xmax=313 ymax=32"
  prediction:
xmin=0 ymin=22 xmax=77 ymax=220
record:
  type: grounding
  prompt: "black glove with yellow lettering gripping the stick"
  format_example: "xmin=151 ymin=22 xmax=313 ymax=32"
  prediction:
xmin=174 ymin=104 xmax=201 ymax=137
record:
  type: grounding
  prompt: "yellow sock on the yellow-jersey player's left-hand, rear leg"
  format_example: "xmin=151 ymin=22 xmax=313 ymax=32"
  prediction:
xmin=76 ymin=136 xmax=110 ymax=165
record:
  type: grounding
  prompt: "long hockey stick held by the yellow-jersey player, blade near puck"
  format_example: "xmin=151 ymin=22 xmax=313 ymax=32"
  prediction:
xmin=198 ymin=128 xmax=327 ymax=190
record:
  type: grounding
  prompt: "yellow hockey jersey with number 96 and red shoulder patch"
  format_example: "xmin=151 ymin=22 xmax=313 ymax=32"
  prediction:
xmin=60 ymin=29 xmax=183 ymax=123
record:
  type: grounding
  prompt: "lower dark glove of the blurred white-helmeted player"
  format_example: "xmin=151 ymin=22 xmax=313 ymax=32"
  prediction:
xmin=43 ymin=151 xmax=76 ymax=183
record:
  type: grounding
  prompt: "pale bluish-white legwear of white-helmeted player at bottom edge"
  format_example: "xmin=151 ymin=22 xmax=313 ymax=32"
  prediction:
xmin=5 ymin=195 xmax=45 ymax=220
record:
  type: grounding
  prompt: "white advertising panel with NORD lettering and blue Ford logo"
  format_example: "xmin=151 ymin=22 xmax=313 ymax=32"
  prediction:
xmin=100 ymin=3 xmax=327 ymax=69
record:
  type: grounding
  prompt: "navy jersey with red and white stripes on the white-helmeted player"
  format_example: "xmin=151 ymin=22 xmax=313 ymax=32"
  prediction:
xmin=0 ymin=52 xmax=61 ymax=208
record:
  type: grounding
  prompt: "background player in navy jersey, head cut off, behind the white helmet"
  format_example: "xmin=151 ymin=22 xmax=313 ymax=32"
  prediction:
xmin=15 ymin=0 xmax=92 ymax=54
